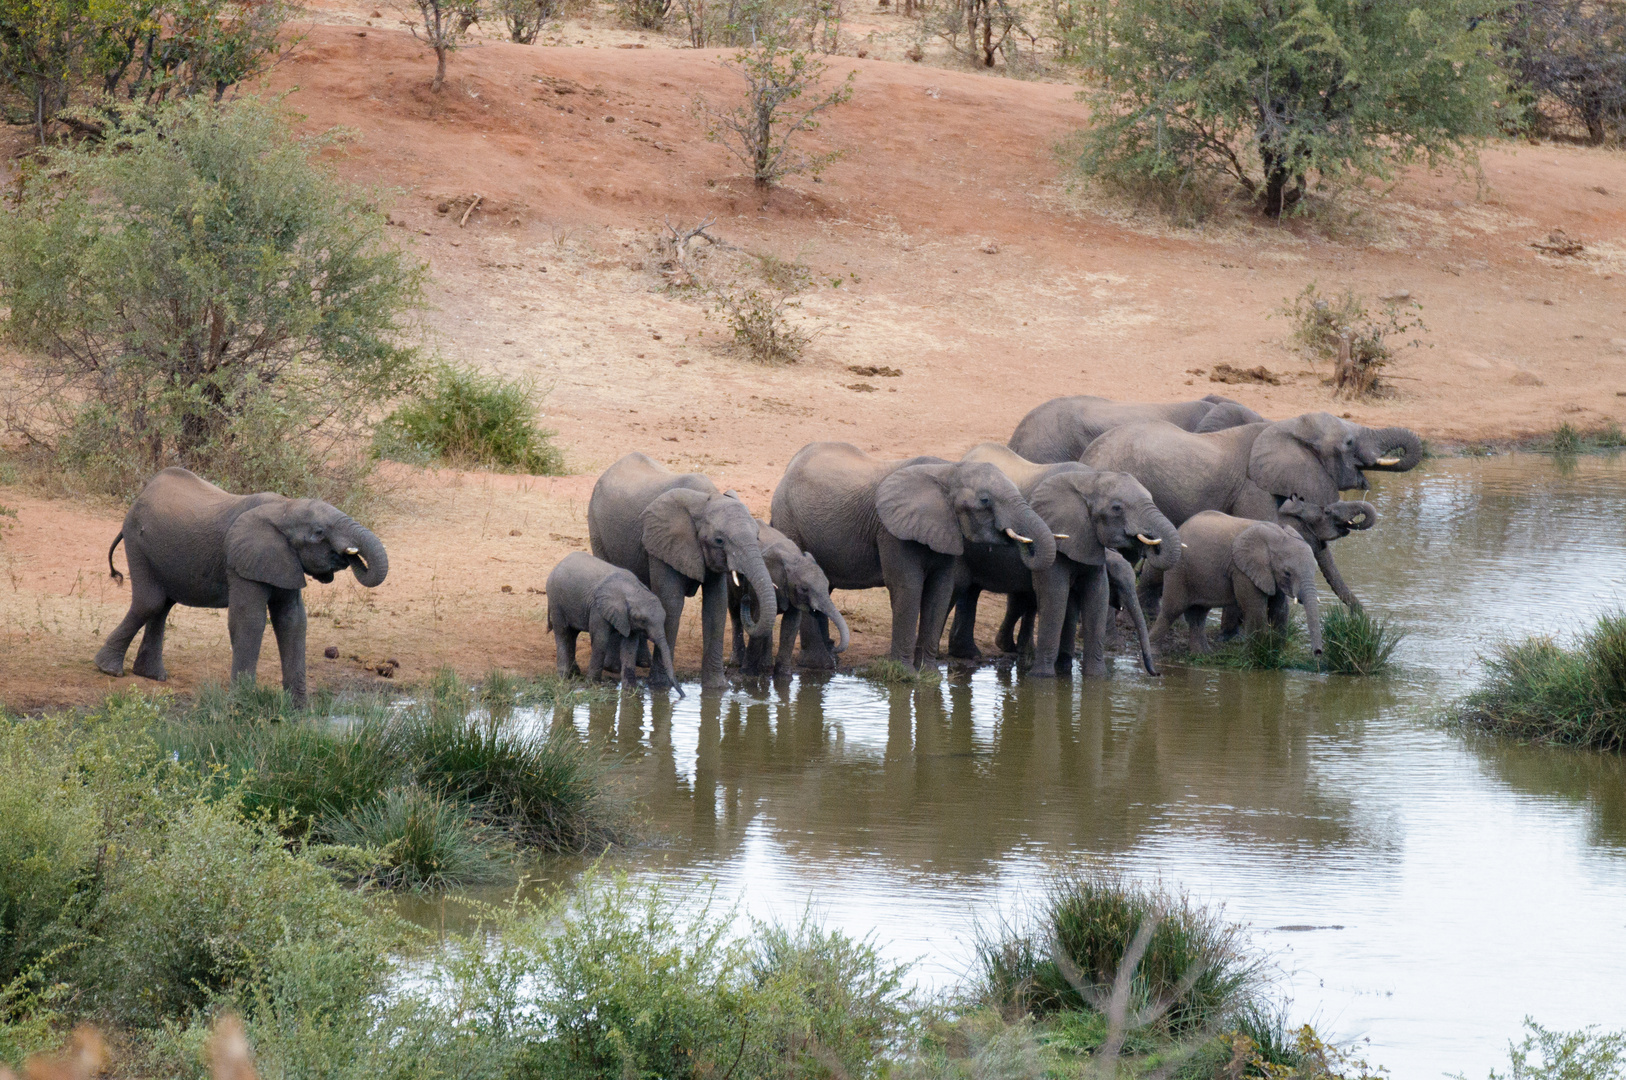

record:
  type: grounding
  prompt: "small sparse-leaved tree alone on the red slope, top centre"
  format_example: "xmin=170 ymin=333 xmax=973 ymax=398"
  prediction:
xmin=694 ymin=34 xmax=859 ymax=187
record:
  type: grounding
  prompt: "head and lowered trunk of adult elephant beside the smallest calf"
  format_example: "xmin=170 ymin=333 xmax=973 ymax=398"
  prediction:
xmin=639 ymin=488 xmax=774 ymax=638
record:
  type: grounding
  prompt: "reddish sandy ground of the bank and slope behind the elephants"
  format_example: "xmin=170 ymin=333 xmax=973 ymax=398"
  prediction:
xmin=0 ymin=5 xmax=1626 ymax=708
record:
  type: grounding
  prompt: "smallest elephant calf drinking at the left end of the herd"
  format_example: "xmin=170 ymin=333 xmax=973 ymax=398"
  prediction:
xmin=548 ymin=551 xmax=683 ymax=698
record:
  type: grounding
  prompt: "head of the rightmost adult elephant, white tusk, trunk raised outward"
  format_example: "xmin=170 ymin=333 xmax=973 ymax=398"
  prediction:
xmin=1247 ymin=413 xmax=1423 ymax=506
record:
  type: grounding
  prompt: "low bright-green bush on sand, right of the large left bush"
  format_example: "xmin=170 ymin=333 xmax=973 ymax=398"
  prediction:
xmin=374 ymin=364 xmax=564 ymax=477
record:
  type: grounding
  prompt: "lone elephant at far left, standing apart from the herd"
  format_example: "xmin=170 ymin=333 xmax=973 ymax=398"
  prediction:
xmin=96 ymin=468 xmax=390 ymax=706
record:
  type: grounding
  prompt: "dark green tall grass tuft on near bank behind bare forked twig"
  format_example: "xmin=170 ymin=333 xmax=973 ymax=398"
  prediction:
xmin=977 ymin=872 xmax=1263 ymax=1036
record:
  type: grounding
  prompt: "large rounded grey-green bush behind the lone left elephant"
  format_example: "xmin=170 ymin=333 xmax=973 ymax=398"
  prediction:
xmin=0 ymin=99 xmax=421 ymax=501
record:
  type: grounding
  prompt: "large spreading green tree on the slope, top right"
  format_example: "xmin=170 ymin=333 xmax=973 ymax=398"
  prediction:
xmin=1080 ymin=0 xmax=1501 ymax=216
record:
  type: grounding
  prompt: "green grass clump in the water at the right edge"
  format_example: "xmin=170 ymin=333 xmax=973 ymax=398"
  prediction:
xmin=1454 ymin=613 xmax=1626 ymax=753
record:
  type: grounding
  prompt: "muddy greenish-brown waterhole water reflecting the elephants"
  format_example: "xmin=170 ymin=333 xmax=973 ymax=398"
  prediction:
xmin=474 ymin=455 xmax=1626 ymax=1078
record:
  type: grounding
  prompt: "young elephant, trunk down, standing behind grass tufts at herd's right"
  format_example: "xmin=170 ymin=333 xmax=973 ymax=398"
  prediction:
xmin=1151 ymin=511 xmax=1322 ymax=655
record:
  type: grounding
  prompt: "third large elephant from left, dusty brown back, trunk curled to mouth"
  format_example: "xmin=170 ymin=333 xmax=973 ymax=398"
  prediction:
xmin=772 ymin=442 xmax=1055 ymax=667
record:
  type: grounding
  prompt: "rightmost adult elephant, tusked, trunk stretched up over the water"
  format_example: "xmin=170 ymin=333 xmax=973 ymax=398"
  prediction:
xmin=1080 ymin=413 xmax=1423 ymax=595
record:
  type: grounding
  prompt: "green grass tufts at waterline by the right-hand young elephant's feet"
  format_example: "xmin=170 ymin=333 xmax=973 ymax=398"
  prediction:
xmin=1179 ymin=603 xmax=1405 ymax=675
